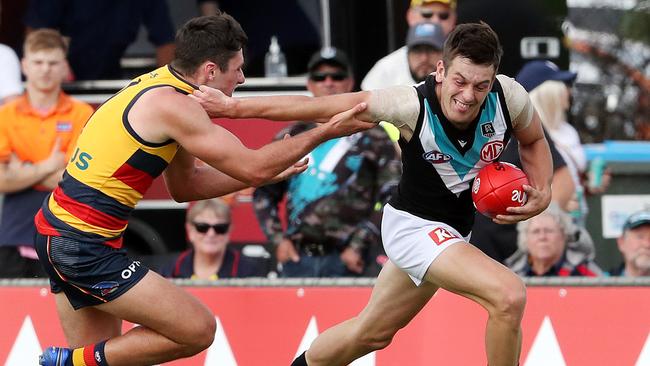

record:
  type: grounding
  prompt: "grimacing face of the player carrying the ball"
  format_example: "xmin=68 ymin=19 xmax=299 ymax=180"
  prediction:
xmin=436 ymin=56 xmax=496 ymax=127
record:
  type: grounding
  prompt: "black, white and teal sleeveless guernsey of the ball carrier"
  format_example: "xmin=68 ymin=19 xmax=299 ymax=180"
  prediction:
xmin=390 ymin=76 xmax=512 ymax=235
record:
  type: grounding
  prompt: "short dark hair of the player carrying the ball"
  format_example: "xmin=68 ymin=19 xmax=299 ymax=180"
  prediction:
xmin=442 ymin=22 xmax=503 ymax=72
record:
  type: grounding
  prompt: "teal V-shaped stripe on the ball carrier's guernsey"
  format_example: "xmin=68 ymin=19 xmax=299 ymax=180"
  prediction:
xmin=424 ymin=92 xmax=499 ymax=180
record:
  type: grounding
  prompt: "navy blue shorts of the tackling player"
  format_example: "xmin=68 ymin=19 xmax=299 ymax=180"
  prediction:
xmin=35 ymin=233 xmax=149 ymax=310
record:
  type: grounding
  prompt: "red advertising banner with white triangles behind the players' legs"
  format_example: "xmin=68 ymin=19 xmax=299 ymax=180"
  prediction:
xmin=0 ymin=287 xmax=650 ymax=366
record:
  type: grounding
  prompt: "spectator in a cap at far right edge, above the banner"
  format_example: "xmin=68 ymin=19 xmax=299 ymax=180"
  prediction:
xmin=611 ymin=210 xmax=650 ymax=277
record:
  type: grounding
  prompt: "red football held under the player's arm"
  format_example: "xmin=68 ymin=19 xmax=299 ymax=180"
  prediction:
xmin=472 ymin=163 xmax=528 ymax=218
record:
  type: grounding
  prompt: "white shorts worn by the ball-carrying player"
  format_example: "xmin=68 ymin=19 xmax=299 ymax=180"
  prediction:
xmin=381 ymin=204 xmax=469 ymax=286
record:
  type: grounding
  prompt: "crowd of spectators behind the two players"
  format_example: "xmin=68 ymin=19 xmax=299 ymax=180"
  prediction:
xmin=0 ymin=0 xmax=650 ymax=280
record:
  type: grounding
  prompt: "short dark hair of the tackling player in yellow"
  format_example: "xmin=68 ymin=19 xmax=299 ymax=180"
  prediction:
xmin=172 ymin=12 xmax=248 ymax=74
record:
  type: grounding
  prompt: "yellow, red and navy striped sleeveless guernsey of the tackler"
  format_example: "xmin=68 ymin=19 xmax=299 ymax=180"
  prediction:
xmin=35 ymin=66 xmax=195 ymax=248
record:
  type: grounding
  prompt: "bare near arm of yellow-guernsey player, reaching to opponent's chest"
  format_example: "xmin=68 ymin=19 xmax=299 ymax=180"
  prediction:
xmin=129 ymin=88 xmax=375 ymax=199
